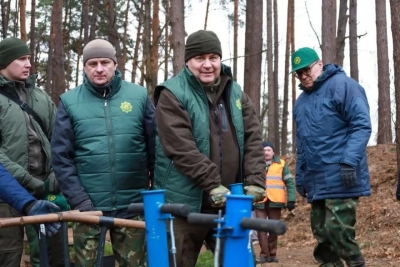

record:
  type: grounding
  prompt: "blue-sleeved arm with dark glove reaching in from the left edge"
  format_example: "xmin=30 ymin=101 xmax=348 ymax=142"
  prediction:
xmin=0 ymin=164 xmax=61 ymax=236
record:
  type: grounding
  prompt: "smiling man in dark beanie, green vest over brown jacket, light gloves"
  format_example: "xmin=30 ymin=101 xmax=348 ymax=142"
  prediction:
xmin=154 ymin=30 xmax=265 ymax=267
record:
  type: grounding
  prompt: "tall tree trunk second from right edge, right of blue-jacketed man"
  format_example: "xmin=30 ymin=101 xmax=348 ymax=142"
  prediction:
xmin=375 ymin=0 xmax=392 ymax=144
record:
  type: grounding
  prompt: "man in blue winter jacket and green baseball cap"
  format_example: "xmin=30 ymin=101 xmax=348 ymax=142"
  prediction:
xmin=292 ymin=47 xmax=371 ymax=267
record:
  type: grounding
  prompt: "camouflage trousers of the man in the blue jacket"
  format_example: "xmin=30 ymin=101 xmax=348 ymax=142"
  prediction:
xmin=310 ymin=198 xmax=365 ymax=267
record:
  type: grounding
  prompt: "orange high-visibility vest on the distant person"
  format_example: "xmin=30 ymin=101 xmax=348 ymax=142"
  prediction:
xmin=264 ymin=159 xmax=286 ymax=204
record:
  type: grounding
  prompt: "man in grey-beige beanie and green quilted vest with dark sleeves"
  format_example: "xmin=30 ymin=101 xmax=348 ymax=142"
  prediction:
xmin=51 ymin=39 xmax=155 ymax=267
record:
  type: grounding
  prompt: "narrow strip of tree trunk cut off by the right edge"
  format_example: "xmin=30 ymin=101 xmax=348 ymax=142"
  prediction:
xmin=390 ymin=0 xmax=400 ymax=172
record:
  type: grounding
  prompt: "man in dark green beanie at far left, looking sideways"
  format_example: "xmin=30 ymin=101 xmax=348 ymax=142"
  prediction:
xmin=0 ymin=37 xmax=64 ymax=267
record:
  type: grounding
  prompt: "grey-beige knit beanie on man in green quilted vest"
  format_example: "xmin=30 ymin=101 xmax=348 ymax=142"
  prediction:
xmin=83 ymin=39 xmax=117 ymax=64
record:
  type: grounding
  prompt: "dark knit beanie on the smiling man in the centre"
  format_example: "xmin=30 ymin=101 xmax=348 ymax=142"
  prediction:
xmin=185 ymin=30 xmax=222 ymax=62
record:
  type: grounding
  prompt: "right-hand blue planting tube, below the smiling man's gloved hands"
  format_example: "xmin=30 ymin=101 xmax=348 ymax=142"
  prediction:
xmin=223 ymin=194 xmax=254 ymax=267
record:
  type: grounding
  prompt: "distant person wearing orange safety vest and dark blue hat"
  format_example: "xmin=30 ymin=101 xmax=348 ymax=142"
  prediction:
xmin=255 ymin=141 xmax=296 ymax=263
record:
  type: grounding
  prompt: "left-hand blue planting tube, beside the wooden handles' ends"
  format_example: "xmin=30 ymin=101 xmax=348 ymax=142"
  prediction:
xmin=142 ymin=190 xmax=170 ymax=267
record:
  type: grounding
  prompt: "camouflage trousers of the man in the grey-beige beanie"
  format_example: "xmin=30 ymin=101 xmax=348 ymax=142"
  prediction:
xmin=73 ymin=215 xmax=147 ymax=267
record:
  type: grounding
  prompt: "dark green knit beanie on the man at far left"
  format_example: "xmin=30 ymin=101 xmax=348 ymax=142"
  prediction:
xmin=0 ymin=37 xmax=31 ymax=70
